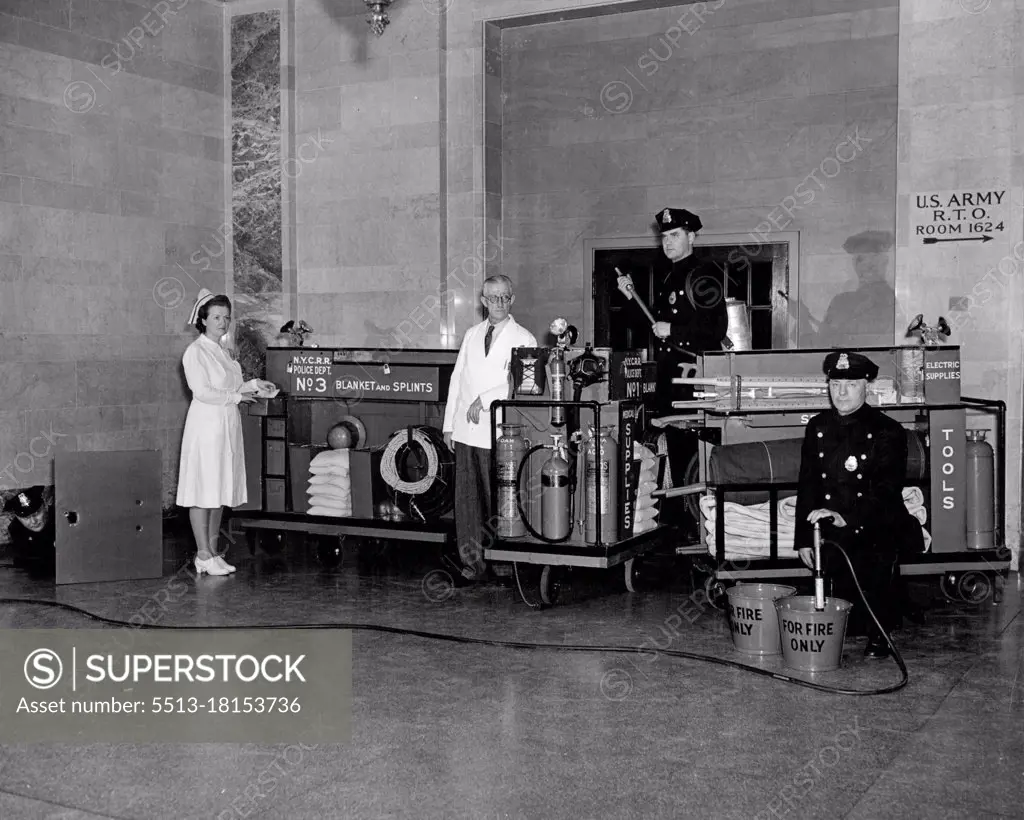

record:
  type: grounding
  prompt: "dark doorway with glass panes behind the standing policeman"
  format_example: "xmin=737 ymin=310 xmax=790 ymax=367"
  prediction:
xmin=593 ymin=236 xmax=796 ymax=356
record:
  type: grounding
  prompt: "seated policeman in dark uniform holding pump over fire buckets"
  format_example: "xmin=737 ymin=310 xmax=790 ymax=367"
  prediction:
xmin=796 ymin=350 xmax=924 ymax=657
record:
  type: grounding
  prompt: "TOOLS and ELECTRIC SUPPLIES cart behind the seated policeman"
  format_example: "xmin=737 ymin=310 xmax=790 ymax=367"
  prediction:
xmin=670 ymin=345 xmax=1011 ymax=603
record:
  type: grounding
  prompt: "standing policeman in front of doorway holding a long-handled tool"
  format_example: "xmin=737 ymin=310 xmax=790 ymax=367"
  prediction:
xmin=616 ymin=208 xmax=731 ymax=523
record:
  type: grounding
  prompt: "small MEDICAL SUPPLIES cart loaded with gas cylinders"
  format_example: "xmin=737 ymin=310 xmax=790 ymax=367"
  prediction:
xmin=484 ymin=400 xmax=664 ymax=609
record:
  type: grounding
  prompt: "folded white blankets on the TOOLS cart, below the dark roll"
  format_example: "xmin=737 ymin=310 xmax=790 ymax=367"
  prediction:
xmin=700 ymin=487 xmax=932 ymax=558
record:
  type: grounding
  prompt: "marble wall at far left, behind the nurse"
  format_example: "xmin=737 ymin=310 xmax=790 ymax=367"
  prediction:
xmin=0 ymin=0 xmax=226 ymax=505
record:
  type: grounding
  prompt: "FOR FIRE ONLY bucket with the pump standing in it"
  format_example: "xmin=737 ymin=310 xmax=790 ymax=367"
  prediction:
xmin=775 ymin=595 xmax=853 ymax=672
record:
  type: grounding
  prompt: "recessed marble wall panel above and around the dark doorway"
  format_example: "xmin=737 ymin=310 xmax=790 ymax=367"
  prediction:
xmin=495 ymin=0 xmax=906 ymax=339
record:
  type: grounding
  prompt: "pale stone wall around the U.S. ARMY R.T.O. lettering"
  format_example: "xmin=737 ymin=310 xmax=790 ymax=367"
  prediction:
xmin=896 ymin=0 xmax=1024 ymax=560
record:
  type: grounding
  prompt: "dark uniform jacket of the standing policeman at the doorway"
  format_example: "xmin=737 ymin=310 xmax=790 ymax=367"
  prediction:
xmin=651 ymin=254 xmax=729 ymax=411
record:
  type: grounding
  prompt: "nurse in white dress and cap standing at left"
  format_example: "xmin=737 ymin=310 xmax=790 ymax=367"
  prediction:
xmin=177 ymin=288 xmax=274 ymax=575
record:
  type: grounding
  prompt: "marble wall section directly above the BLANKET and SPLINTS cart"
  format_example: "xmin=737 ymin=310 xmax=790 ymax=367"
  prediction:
xmin=292 ymin=0 xmax=446 ymax=348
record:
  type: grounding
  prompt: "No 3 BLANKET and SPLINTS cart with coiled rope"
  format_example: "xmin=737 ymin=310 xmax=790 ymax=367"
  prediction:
xmin=232 ymin=347 xmax=458 ymax=566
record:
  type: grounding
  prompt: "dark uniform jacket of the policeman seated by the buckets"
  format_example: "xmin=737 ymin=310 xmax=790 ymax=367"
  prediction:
xmin=795 ymin=404 xmax=924 ymax=556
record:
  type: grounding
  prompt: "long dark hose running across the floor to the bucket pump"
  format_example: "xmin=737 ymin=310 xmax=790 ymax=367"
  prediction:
xmin=0 ymin=542 xmax=909 ymax=696
